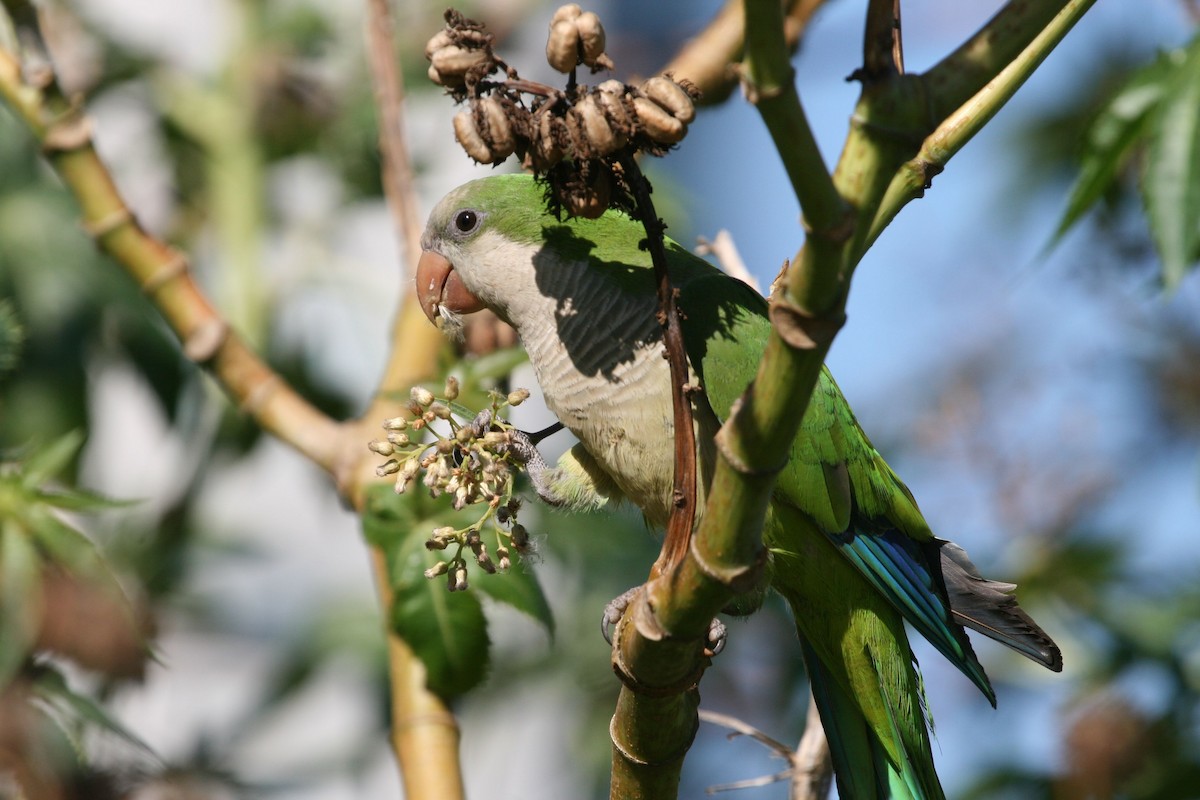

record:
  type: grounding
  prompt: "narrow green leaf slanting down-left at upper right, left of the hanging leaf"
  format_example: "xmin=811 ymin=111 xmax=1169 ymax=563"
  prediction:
xmin=1054 ymin=55 xmax=1177 ymax=240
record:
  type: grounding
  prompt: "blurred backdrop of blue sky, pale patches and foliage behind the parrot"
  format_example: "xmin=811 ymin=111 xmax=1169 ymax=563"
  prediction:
xmin=0 ymin=0 xmax=1200 ymax=800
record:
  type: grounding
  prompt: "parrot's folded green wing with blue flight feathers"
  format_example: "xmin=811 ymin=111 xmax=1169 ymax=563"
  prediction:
xmin=679 ymin=268 xmax=995 ymax=704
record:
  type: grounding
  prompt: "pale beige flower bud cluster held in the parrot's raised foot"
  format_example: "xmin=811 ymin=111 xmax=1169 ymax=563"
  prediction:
xmin=367 ymin=378 xmax=533 ymax=591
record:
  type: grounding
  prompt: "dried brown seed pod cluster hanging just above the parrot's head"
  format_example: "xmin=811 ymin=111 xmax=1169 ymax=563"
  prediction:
xmin=426 ymin=4 xmax=698 ymax=217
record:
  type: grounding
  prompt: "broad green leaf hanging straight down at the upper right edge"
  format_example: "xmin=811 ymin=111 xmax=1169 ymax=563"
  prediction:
xmin=1141 ymin=37 xmax=1200 ymax=288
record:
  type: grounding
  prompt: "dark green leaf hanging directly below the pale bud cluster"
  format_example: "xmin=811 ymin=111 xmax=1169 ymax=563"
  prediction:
xmin=362 ymin=485 xmax=490 ymax=700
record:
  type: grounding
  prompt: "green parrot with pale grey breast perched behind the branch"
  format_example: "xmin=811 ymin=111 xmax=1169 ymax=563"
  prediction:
xmin=416 ymin=175 xmax=1062 ymax=800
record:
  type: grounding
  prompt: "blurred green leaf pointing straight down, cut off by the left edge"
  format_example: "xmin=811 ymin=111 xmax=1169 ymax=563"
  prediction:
xmin=0 ymin=521 xmax=42 ymax=686
